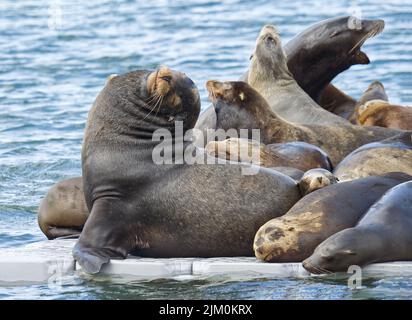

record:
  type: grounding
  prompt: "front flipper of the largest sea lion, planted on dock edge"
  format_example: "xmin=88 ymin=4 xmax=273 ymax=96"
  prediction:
xmin=73 ymin=198 xmax=136 ymax=274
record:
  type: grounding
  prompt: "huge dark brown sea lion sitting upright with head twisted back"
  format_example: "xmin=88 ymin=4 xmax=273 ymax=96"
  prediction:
xmin=73 ymin=67 xmax=301 ymax=273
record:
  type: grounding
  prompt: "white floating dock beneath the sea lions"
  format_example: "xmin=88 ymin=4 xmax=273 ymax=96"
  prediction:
xmin=0 ymin=240 xmax=412 ymax=283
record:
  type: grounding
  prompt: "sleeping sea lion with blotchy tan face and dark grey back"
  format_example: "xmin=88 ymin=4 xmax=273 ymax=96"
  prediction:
xmin=254 ymin=173 xmax=412 ymax=262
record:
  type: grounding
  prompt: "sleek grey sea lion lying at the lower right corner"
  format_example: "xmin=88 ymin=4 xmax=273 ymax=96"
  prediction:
xmin=303 ymin=181 xmax=412 ymax=274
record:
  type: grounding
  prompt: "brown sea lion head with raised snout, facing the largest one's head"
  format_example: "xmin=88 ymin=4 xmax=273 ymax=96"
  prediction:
xmin=206 ymin=80 xmax=270 ymax=136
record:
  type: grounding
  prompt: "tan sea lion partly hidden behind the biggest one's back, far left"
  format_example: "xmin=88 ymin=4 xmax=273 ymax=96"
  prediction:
xmin=38 ymin=177 xmax=89 ymax=239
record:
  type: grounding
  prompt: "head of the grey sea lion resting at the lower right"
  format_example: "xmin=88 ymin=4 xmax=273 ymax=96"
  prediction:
xmin=302 ymin=228 xmax=379 ymax=274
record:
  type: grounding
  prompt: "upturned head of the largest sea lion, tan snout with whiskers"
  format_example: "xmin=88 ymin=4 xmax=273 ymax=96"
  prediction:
xmin=146 ymin=66 xmax=200 ymax=128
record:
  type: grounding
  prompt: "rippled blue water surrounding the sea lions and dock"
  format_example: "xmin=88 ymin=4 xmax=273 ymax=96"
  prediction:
xmin=0 ymin=0 xmax=412 ymax=299
